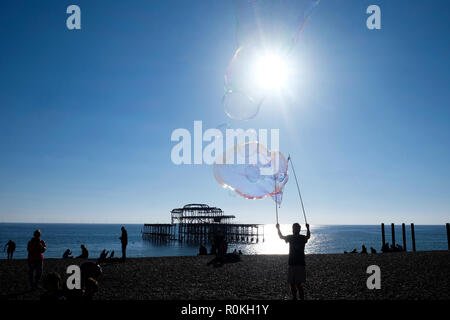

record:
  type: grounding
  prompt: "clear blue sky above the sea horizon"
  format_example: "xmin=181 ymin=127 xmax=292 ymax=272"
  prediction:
xmin=0 ymin=0 xmax=450 ymax=224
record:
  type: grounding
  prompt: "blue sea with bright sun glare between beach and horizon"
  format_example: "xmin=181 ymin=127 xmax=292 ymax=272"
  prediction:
xmin=0 ymin=223 xmax=448 ymax=259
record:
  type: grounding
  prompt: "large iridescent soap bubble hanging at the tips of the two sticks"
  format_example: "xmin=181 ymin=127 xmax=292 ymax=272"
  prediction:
xmin=213 ymin=142 xmax=288 ymax=204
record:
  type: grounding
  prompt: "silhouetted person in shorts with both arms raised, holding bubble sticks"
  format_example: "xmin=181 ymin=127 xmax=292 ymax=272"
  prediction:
xmin=276 ymin=223 xmax=311 ymax=300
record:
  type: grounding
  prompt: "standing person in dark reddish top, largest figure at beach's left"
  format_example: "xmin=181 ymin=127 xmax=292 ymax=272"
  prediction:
xmin=27 ymin=230 xmax=47 ymax=290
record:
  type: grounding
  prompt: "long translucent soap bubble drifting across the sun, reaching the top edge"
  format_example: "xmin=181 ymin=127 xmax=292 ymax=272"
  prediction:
xmin=223 ymin=0 xmax=319 ymax=120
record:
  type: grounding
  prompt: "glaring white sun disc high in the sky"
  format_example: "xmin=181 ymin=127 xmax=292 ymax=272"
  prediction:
xmin=255 ymin=53 xmax=288 ymax=90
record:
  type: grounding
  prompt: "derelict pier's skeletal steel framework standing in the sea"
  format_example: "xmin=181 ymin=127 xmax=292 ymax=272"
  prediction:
xmin=142 ymin=204 xmax=264 ymax=243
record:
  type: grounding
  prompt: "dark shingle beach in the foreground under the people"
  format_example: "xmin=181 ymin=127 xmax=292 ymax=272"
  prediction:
xmin=0 ymin=251 xmax=450 ymax=300
